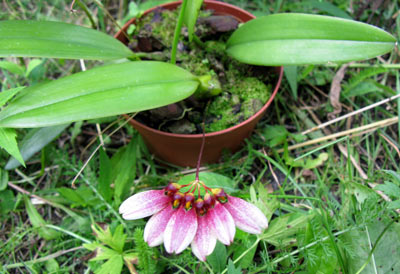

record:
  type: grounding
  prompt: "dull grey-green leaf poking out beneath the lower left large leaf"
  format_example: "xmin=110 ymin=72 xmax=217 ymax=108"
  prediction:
xmin=5 ymin=124 xmax=69 ymax=170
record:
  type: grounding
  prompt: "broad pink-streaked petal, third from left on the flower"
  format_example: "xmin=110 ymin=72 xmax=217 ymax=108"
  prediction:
xmin=164 ymin=207 xmax=197 ymax=254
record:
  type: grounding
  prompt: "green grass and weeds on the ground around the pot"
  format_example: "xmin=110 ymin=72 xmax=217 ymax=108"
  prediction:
xmin=0 ymin=0 xmax=400 ymax=274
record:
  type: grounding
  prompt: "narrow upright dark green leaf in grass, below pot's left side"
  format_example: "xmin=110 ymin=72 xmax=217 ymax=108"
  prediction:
xmin=98 ymin=148 xmax=112 ymax=202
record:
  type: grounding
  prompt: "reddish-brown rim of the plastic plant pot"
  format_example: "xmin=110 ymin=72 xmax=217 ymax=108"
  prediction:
xmin=114 ymin=0 xmax=283 ymax=139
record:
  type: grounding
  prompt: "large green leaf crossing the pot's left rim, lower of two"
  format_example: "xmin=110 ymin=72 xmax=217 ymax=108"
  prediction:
xmin=0 ymin=61 xmax=198 ymax=127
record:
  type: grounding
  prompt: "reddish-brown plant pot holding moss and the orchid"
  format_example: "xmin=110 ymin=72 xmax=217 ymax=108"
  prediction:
xmin=115 ymin=0 xmax=283 ymax=167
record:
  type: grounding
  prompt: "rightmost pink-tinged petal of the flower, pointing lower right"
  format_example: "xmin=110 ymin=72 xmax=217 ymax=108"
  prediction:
xmin=224 ymin=196 xmax=268 ymax=234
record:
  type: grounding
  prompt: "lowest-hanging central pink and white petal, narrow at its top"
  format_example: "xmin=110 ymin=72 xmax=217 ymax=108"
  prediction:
xmin=192 ymin=215 xmax=217 ymax=262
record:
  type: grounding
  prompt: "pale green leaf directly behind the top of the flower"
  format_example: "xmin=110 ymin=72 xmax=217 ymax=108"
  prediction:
xmin=177 ymin=172 xmax=237 ymax=194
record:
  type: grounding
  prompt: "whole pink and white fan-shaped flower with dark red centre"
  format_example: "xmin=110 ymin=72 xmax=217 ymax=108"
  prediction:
xmin=119 ymin=180 xmax=268 ymax=261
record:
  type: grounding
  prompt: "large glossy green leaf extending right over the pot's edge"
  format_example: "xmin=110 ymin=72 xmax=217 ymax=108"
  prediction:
xmin=227 ymin=13 xmax=396 ymax=65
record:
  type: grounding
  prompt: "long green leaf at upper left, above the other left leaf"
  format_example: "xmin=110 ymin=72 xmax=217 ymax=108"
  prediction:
xmin=0 ymin=20 xmax=134 ymax=60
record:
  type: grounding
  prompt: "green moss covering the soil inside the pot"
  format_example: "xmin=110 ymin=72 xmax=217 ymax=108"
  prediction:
xmin=136 ymin=10 xmax=271 ymax=133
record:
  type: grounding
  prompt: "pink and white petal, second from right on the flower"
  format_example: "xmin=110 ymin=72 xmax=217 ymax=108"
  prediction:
xmin=207 ymin=202 xmax=236 ymax=245
